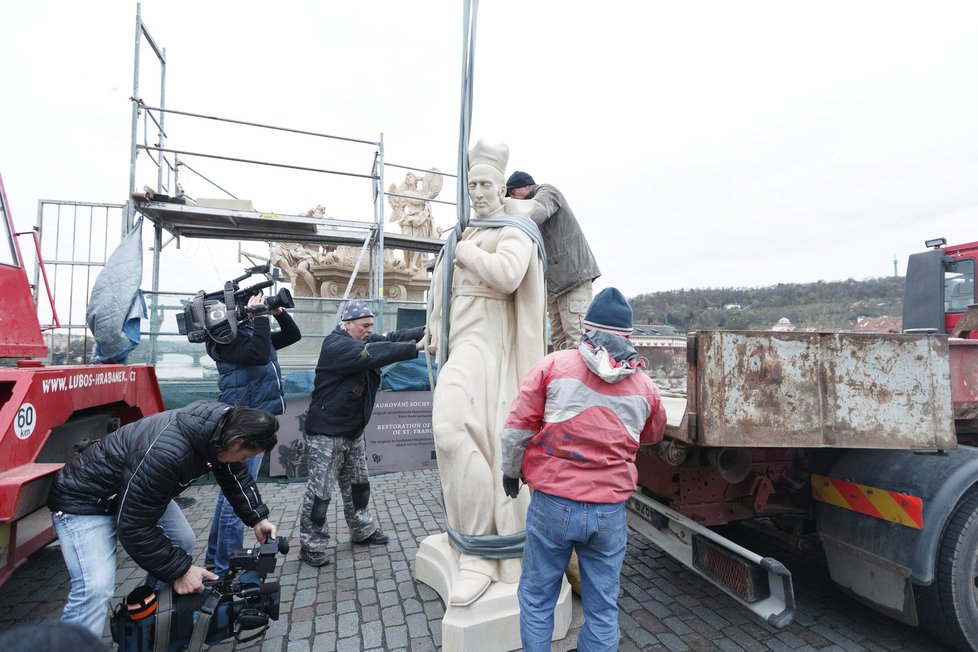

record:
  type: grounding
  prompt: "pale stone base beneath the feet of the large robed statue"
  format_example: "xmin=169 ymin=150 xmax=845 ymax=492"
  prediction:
xmin=414 ymin=533 xmax=572 ymax=652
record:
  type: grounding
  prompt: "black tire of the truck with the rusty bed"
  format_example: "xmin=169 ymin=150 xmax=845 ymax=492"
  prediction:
xmin=914 ymin=488 xmax=978 ymax=650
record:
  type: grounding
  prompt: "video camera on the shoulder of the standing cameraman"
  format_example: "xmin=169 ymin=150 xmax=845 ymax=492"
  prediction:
xmin=177 ymin=264 xmax=295 ymax=344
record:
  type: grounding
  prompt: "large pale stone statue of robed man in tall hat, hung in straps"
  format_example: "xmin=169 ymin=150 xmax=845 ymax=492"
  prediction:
xmin=428 ymin=141 xmax=546 ymax=607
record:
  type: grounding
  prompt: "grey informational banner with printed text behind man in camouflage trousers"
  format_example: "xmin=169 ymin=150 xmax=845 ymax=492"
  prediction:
xmin=269 ymin=391 xmax=438 ymax=478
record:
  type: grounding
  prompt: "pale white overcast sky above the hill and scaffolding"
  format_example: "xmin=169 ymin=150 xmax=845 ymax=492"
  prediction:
xmin=0 ymin=0 xmax=978 ymax=296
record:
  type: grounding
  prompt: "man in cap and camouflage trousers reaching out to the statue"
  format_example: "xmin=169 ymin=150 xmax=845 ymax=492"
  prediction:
xmin=299 ymin=299 xmax=424 ymax=566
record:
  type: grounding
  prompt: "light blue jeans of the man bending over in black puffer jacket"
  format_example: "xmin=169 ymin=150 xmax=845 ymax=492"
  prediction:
xmin=51 ymin=500 xmax=197 ymax=637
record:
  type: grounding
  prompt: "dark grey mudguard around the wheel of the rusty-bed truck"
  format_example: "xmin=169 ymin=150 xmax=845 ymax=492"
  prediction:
xmin=816 ymin=446 xmax=978 ymax=585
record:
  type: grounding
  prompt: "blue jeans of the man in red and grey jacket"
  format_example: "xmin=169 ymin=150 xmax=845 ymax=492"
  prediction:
xmin=517 ymin=491 xmax=628 ymax=652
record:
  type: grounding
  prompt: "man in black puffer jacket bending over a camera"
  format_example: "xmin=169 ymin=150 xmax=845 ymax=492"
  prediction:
xmin=48 ymin=401 xmax=278 ymax=636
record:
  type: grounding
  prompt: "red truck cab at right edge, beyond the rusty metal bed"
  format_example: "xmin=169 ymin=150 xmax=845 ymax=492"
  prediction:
xmin=903 ymin=238 xmax=978 ymax=339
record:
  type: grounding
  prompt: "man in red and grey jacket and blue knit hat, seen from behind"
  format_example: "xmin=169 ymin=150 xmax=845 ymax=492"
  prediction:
xmin=501 ymin=288 xmax=666 ymax=652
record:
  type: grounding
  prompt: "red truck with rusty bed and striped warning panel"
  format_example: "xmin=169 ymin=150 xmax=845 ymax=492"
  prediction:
xmin=629 ymin=239 xmax=978 ymax=650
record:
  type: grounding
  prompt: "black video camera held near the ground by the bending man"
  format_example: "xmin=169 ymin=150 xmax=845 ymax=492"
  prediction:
xmin=111 ymin=537 xmax=289 ymax=652
